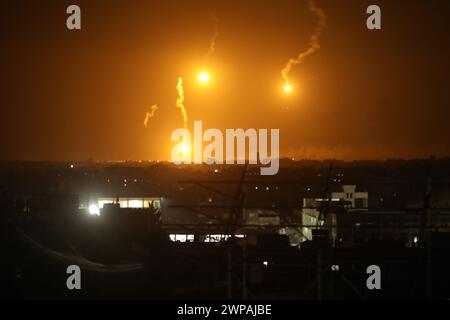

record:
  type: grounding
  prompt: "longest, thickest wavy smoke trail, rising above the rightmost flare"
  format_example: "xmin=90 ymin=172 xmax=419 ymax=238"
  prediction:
xmin=281 ymin=0 xmax=327 ymax=84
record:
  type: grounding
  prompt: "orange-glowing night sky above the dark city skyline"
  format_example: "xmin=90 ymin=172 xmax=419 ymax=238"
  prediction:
xmin=0 ymin=0 xmax=450 ymax=160
